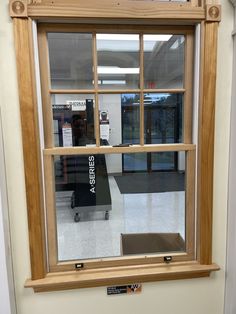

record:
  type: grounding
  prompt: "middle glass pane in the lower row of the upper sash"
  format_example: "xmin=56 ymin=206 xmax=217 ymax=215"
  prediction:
xmin=99 ymin=94 xmax=140 ymax=146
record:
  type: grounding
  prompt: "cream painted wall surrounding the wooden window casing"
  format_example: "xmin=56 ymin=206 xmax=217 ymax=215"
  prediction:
xmin=0 ymin=0 xmax=233 ymax=314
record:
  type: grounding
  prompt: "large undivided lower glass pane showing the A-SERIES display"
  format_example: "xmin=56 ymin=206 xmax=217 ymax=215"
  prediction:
xmin=54 ymin=152 xmax=186 ymax=261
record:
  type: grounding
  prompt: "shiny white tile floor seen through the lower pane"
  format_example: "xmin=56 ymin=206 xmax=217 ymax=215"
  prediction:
xmin=56 ymin=176 xmax=185 ymax=261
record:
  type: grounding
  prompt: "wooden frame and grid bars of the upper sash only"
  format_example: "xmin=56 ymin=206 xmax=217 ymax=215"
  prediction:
xmin=39 ymin=25 xmax=193 ymax=148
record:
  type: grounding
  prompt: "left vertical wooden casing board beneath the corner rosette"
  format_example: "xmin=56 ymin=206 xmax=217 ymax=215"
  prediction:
xmin=13 ymin=19 xmax=46 ymax=279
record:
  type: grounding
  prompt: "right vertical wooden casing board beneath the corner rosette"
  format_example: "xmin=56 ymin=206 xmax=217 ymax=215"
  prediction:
xmin=198 ymin=22 xmax=218 ymax=264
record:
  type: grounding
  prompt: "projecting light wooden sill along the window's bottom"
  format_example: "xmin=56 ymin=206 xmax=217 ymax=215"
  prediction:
xmin=25 ymin=262 xmax=220 ymax=292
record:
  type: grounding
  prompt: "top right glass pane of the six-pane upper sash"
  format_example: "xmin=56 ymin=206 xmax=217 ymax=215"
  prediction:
xmin=144 ymin=34 xmax=185 ymax=89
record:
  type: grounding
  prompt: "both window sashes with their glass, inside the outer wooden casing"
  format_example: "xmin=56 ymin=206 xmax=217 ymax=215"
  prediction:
xmin=39 ymin=25 xmax=196 ymax=270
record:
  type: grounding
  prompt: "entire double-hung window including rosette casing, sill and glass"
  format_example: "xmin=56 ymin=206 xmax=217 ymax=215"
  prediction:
xmin=10 ymin=0 xmax=220 ymax=291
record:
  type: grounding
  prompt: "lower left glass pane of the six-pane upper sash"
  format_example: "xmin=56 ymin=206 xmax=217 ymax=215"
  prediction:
xmin=51 ymin=94 xmax=95 ymax=147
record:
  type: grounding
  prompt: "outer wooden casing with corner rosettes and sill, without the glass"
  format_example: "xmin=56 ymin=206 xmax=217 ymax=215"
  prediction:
xmin=10 ymin=0 xmax=220 ymax=292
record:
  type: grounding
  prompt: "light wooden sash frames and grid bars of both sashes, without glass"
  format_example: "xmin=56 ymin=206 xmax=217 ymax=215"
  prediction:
xmin=38 ymin=23 xmax=196 ymax=272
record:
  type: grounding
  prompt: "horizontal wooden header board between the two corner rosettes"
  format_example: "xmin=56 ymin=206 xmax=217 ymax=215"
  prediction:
xmin=28 ymin=0 xmax=205 ymax=21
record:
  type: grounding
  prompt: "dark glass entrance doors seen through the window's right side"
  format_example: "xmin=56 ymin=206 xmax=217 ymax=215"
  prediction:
xmin=122 ymin=94 xmax=183 ymax=172
